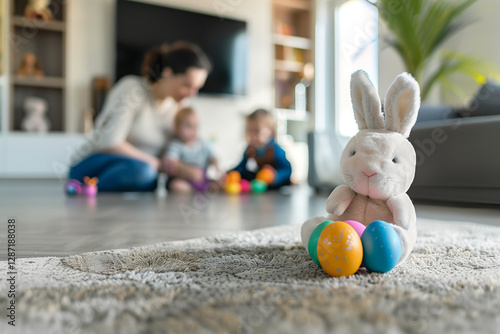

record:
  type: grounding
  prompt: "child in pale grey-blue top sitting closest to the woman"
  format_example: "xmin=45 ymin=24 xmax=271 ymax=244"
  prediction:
xmin=164 ymin=108 xmax=218 ymax=193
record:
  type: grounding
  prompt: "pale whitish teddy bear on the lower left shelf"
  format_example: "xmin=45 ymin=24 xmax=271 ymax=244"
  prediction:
xmin=21 ymin=96 xmax=50 ymax=133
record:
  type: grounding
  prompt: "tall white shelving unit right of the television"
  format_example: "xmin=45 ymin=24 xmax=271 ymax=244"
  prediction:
xmin=272 ymin=0 xmax=315 ymax=182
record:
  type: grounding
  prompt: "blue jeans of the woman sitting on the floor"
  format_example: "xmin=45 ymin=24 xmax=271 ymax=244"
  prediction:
xmin=69 ymin=153 xmax=158 ymax=191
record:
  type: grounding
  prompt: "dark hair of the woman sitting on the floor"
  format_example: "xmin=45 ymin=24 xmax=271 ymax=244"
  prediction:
xmin=142 ymin=42 xmax=212 ymax=83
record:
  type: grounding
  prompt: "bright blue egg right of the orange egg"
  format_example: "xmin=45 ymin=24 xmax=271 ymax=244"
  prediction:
xmin=361 ymin=220 xmax=401 ymax=273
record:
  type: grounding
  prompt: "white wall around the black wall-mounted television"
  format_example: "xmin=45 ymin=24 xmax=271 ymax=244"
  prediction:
xmin=67 ymin=0 xmax=273 ymax=167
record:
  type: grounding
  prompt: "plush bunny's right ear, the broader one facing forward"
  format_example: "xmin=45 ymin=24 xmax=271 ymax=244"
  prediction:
xmin=384 ymin=73 xmax=420 ymax=138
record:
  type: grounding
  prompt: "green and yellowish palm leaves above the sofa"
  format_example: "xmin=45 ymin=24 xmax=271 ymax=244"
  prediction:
xmin=373 ymin=0 xmax=498 ymax=100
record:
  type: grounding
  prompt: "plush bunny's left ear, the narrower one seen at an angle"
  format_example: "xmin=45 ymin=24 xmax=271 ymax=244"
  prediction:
xmin=351 ymin=70 xmax=384 ymax=130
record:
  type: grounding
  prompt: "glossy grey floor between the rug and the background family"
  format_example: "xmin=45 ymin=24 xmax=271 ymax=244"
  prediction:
xmin=0 ymin=180 xmax=500 ymax=260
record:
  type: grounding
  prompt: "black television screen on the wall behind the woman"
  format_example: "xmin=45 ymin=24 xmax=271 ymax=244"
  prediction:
xmin=115 ymin=0 xmax=247 ymax=95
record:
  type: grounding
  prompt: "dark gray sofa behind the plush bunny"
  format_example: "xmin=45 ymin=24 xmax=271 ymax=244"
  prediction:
xmin=308 ymin=83 xmax=500 ymax=204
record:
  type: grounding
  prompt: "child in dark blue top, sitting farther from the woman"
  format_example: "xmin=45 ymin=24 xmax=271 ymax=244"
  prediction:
xmin=233 ymin=109 xmax=292 ymax=189
